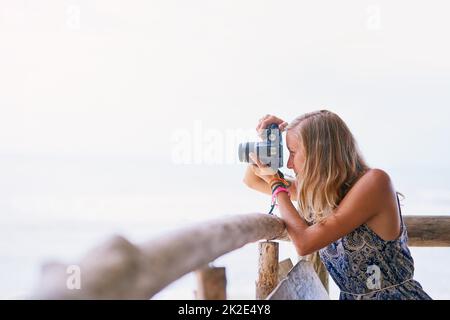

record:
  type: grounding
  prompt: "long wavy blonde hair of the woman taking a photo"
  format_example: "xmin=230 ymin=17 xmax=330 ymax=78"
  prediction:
xmin=286 ymin=110 xmax=370 ymax=224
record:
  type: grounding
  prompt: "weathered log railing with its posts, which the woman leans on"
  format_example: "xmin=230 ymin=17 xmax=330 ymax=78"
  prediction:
xmin=30 ymin=213 xmax=450 ymax=299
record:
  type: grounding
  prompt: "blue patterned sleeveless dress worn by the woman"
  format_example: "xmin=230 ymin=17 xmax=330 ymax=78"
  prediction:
xmin=319 ymin=197 xmax=431 ymax=300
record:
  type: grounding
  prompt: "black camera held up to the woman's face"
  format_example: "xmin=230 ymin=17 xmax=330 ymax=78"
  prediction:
xmin=238 ymin=123 xmax=283 ymax=171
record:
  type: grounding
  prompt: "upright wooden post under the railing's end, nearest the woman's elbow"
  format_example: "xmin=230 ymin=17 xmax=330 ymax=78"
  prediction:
xmin=256 ymin=241 xmax=278 ymax=300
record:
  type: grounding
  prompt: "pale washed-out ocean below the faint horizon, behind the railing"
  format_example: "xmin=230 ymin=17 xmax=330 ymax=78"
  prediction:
xmin=0 ymin=159 xmax=450 ymax=299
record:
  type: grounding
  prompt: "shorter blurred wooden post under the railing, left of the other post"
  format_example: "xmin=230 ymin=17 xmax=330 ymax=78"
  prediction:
xmin=196 ymin=266 xmax=227 ymax=300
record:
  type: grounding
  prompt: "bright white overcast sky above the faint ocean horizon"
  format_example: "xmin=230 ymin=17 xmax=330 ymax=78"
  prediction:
xmin=0 ymin=0 xmax=450 ymax=215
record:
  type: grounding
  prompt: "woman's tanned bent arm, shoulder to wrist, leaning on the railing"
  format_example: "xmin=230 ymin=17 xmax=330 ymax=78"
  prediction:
xmin=277 ymin=169 xmax=393 ymax=256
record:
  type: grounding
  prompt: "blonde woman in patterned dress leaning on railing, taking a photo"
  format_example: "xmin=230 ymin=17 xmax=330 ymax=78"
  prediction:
xmin=244 ymin=110 xmax=431 ymax=299
